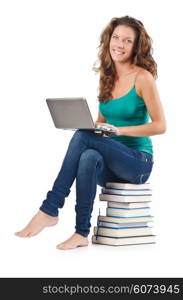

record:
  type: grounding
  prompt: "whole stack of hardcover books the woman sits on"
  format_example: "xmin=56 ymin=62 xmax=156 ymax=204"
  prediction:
xmin=92 ymin=182 xmax=155 ymax=246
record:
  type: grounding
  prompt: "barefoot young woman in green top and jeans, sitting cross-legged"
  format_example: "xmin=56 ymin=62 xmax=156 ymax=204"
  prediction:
xmin=16 ymin=16 xmax=166 ymax=250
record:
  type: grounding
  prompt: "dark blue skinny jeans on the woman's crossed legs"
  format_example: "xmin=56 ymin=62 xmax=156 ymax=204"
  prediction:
xmin=40 ymin=129 xmax=153 ymax=237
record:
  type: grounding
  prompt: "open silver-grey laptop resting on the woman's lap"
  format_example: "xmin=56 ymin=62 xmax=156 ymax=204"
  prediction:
xmin=46 ymin=97 xmax=115 ymax=134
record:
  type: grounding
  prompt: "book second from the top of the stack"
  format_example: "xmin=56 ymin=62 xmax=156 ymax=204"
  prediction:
xmin=101 ymin=188 xmax=152 ymax=196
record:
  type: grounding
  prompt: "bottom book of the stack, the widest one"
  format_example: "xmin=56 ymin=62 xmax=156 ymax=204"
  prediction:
xmin=92 ymin=235 xmax=155 ymax=246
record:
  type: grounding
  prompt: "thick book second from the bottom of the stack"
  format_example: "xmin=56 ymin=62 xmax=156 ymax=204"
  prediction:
xmin=94 ymin=226 xmax=152 ymax=237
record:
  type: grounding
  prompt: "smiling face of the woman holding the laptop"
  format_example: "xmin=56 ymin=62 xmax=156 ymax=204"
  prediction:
xmin=109 ymin=25 xmax=136 ymax=63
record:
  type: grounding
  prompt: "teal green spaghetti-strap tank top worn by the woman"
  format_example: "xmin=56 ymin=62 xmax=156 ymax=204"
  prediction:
xmin=99 ymin=85 xmax=153 ymax=154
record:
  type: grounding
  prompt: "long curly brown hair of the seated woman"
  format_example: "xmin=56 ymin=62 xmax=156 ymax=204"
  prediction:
xmin=93 ymin=16 xmax=157 ymax=102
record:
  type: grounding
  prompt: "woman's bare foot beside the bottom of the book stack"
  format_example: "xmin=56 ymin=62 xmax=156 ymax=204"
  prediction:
xmin=57 ymin=233 xmax=89 ymax=250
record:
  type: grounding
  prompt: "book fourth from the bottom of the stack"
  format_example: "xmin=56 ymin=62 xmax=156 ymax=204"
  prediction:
xmin=98 ymin=216 xmax=154 ymax=224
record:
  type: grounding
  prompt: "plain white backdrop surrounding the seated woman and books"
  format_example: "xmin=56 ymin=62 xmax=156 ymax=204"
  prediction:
xmin=0 ymin=0 xmax=183 ymax=277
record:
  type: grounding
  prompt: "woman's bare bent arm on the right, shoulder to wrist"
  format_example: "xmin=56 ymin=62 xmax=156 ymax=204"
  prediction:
xmin=118 ymin=70 xmax=166 ymax=137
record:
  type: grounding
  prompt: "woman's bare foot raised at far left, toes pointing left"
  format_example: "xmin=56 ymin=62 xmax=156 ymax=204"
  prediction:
xmin=15 ymin=210 xmax=58 ymax=237
